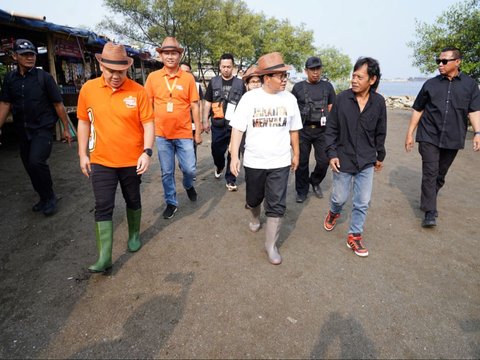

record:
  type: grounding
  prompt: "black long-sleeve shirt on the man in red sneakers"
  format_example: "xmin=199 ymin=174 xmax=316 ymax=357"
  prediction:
xmin=325 ymin=89 xmax=387 ymax=173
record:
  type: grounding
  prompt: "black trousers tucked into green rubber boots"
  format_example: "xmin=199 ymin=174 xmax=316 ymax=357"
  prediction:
xmin=90 ymin=164 xmax=142 ymax=221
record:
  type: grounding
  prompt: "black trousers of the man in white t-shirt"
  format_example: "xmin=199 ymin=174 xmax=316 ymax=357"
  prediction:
xmin=245 ymin=166 xmax=290 ymax=217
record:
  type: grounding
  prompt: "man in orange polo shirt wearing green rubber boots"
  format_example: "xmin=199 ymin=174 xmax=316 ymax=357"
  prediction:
xmin=77 ymin=42 xmax=154 ymax=272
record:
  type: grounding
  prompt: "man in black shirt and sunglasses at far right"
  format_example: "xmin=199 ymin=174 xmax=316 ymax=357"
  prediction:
xmin=405 ymin=47 xmax=480 ymax=228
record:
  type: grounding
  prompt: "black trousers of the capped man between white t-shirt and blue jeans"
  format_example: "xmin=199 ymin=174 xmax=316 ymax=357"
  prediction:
xmin=295 ymin=127 xmax=329 ymax=195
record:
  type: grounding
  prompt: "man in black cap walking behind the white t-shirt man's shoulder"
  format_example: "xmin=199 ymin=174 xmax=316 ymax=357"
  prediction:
xmin=292 ymin=56 xmax=335 ymax=203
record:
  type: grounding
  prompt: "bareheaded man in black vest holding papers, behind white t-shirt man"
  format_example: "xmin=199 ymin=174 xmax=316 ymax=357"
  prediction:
xmin=203 ymin=54 xmax=246 ymax=191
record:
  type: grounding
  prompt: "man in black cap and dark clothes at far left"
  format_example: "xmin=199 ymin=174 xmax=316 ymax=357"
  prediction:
xmin=0 ymin=39 xmax=72 ymax=216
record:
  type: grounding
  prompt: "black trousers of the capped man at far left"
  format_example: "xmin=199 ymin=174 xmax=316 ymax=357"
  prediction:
xmin=18 ymin=127 xmax=54 ymax=201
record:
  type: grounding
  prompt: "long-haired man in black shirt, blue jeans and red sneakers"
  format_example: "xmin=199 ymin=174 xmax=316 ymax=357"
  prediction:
xmin=323 ymin=57 xmax=387 ymax=257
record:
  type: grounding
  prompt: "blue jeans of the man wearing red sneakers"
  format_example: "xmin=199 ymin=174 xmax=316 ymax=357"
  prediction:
xmin=330 ymin=166 xmax=374 ymax=234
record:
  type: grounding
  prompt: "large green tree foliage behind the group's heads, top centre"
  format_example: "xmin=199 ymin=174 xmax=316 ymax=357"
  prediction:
xmin=99 ymin=0 xmax=314 ymax=75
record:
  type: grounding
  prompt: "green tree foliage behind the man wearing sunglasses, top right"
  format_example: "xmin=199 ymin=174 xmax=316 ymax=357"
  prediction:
xmin=407 ymin=0 xmax=480 ymax=80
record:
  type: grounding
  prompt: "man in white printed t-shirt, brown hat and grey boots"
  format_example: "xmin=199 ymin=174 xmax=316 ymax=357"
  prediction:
xmin=230 ymin=52 xmax=303 ymax=265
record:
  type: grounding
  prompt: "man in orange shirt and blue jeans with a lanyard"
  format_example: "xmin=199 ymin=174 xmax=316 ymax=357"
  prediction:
xmin=145 ymin=37 xmax=202 ymax=219
